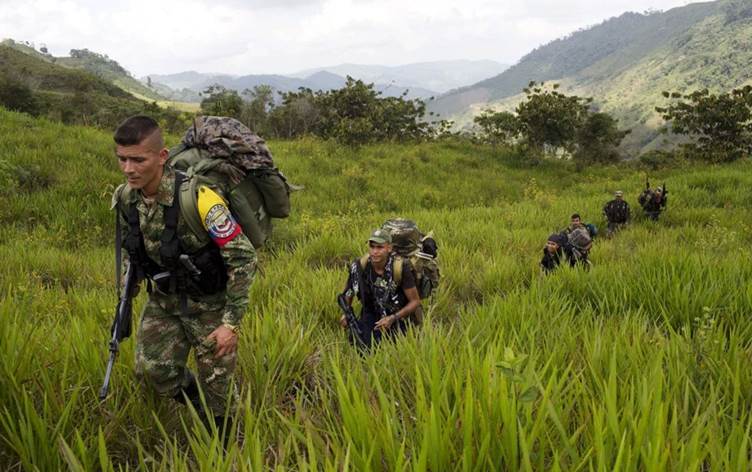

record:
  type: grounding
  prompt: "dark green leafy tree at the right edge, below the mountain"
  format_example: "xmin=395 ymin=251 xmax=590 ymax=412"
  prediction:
xmin=656 ymin=85 xmax=752 ymax=162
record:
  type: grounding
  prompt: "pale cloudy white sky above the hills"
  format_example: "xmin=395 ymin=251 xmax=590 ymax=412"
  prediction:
xmin=0 ymin=0 xmax=693 ymax=77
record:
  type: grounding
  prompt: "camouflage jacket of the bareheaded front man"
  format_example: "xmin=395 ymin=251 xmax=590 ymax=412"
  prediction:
xmin=113 ymin=166 xmax=256 ymax=325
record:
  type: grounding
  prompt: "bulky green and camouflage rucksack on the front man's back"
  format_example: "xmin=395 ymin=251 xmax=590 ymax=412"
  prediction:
xmin=167 ymin=116 xmax=291 ymax=248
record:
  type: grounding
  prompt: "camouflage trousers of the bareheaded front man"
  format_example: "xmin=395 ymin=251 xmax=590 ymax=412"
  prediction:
xmin=136 ymin=292 xmax=237 ymax=416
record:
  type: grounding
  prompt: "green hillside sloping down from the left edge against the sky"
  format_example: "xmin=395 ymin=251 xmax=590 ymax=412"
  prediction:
xmin=0 ymin=39 xmax=164 ymax=100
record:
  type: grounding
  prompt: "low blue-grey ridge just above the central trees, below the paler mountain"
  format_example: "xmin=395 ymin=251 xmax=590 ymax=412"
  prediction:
xmin=142 ymin=70 xmax=438 ymax=101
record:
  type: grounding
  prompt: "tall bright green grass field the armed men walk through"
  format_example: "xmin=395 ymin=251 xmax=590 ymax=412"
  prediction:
xmin=0 ymin=111 xmax=752 ymax=471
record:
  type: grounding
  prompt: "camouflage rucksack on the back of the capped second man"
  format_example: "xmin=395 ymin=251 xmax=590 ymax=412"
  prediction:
xmin=381 ymin=218 xmax=441 ymax=299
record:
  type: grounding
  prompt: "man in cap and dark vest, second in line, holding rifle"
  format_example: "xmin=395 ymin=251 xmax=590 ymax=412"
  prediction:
xmin=340 ymin=229 xmax=420 ymax=346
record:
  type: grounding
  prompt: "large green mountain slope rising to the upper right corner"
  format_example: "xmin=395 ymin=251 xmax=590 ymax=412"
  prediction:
xmin=429 ymin=0 xmax=752 ymax=150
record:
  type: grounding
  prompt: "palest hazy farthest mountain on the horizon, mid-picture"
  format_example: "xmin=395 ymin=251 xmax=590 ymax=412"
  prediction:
xmin=293 ymin=60 xmax=509 ymax=93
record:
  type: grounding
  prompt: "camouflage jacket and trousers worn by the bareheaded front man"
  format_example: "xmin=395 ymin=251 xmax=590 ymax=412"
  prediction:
xmin=115 ymin=166 xmax=256 ymax=416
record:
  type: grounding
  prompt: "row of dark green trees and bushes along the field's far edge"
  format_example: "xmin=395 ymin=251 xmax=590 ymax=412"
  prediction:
xmin=0 ymin=63 xmax=752 ymax=165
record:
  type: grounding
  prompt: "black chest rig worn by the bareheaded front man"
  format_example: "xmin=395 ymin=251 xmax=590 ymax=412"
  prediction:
xmin=117 ymin=172 xmax=227 ymax=312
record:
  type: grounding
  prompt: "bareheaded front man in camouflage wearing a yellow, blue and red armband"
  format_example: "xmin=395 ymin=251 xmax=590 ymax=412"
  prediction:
xmin=113 ymin=116 xmax=256 ymax=440
